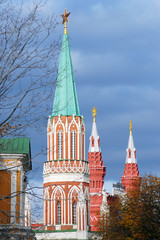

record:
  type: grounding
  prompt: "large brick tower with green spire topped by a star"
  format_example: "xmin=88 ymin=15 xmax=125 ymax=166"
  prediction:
xmin=43 ymin=9 xmax=90 ymax=239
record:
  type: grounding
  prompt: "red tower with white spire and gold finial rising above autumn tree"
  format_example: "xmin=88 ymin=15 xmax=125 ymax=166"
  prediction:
xmin=121 ymin=121 xmax=141 ymax=192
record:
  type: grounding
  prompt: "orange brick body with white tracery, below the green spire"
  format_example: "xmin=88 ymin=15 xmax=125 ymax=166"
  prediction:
xmin=43 ymin=115 xmax=90 ymax=236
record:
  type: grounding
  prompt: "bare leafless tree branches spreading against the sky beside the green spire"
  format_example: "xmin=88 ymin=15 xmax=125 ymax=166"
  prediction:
xmin=0 ymin=0 xmax=60 ymax=137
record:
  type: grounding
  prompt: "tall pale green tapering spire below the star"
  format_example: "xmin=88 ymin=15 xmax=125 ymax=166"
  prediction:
xmin=52 ymin=33 xmax=80 ymax=116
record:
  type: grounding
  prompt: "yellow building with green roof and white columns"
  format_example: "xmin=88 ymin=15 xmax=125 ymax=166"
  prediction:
xmin=0 ymin=138 xmax=32 ymax=239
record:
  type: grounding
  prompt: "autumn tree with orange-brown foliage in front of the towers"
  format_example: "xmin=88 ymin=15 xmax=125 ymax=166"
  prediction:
xmin=99 ymin=175 xmax=160 ymax=240
